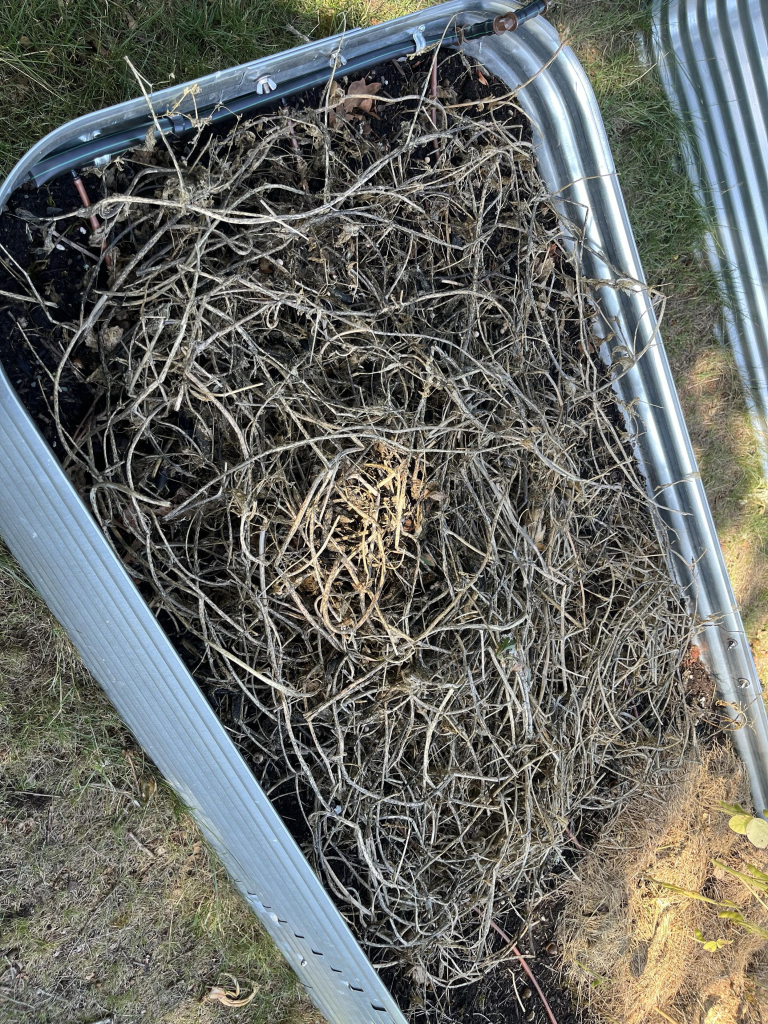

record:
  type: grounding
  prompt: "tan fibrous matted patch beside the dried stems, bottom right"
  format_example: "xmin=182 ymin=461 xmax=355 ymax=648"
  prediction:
xmin=561 ymin=748 xmax=768 ymax=1024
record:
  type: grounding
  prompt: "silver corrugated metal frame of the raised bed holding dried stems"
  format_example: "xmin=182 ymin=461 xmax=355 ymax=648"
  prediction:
xmin=0 ymin=0 xmax=768 ymax=1024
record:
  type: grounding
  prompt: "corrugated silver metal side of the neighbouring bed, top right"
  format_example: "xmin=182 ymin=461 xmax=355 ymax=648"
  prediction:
xmin=653 ymin=0 xmax=768 ymax=479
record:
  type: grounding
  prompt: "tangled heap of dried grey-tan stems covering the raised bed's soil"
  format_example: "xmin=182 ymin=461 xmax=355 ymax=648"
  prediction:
xmin=52 ymin=59 xmax=689 ymax=985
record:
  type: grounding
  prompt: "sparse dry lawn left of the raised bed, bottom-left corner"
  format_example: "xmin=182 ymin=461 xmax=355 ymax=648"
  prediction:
xmin=0 ymin=556 xmax=313 ymax=1024
